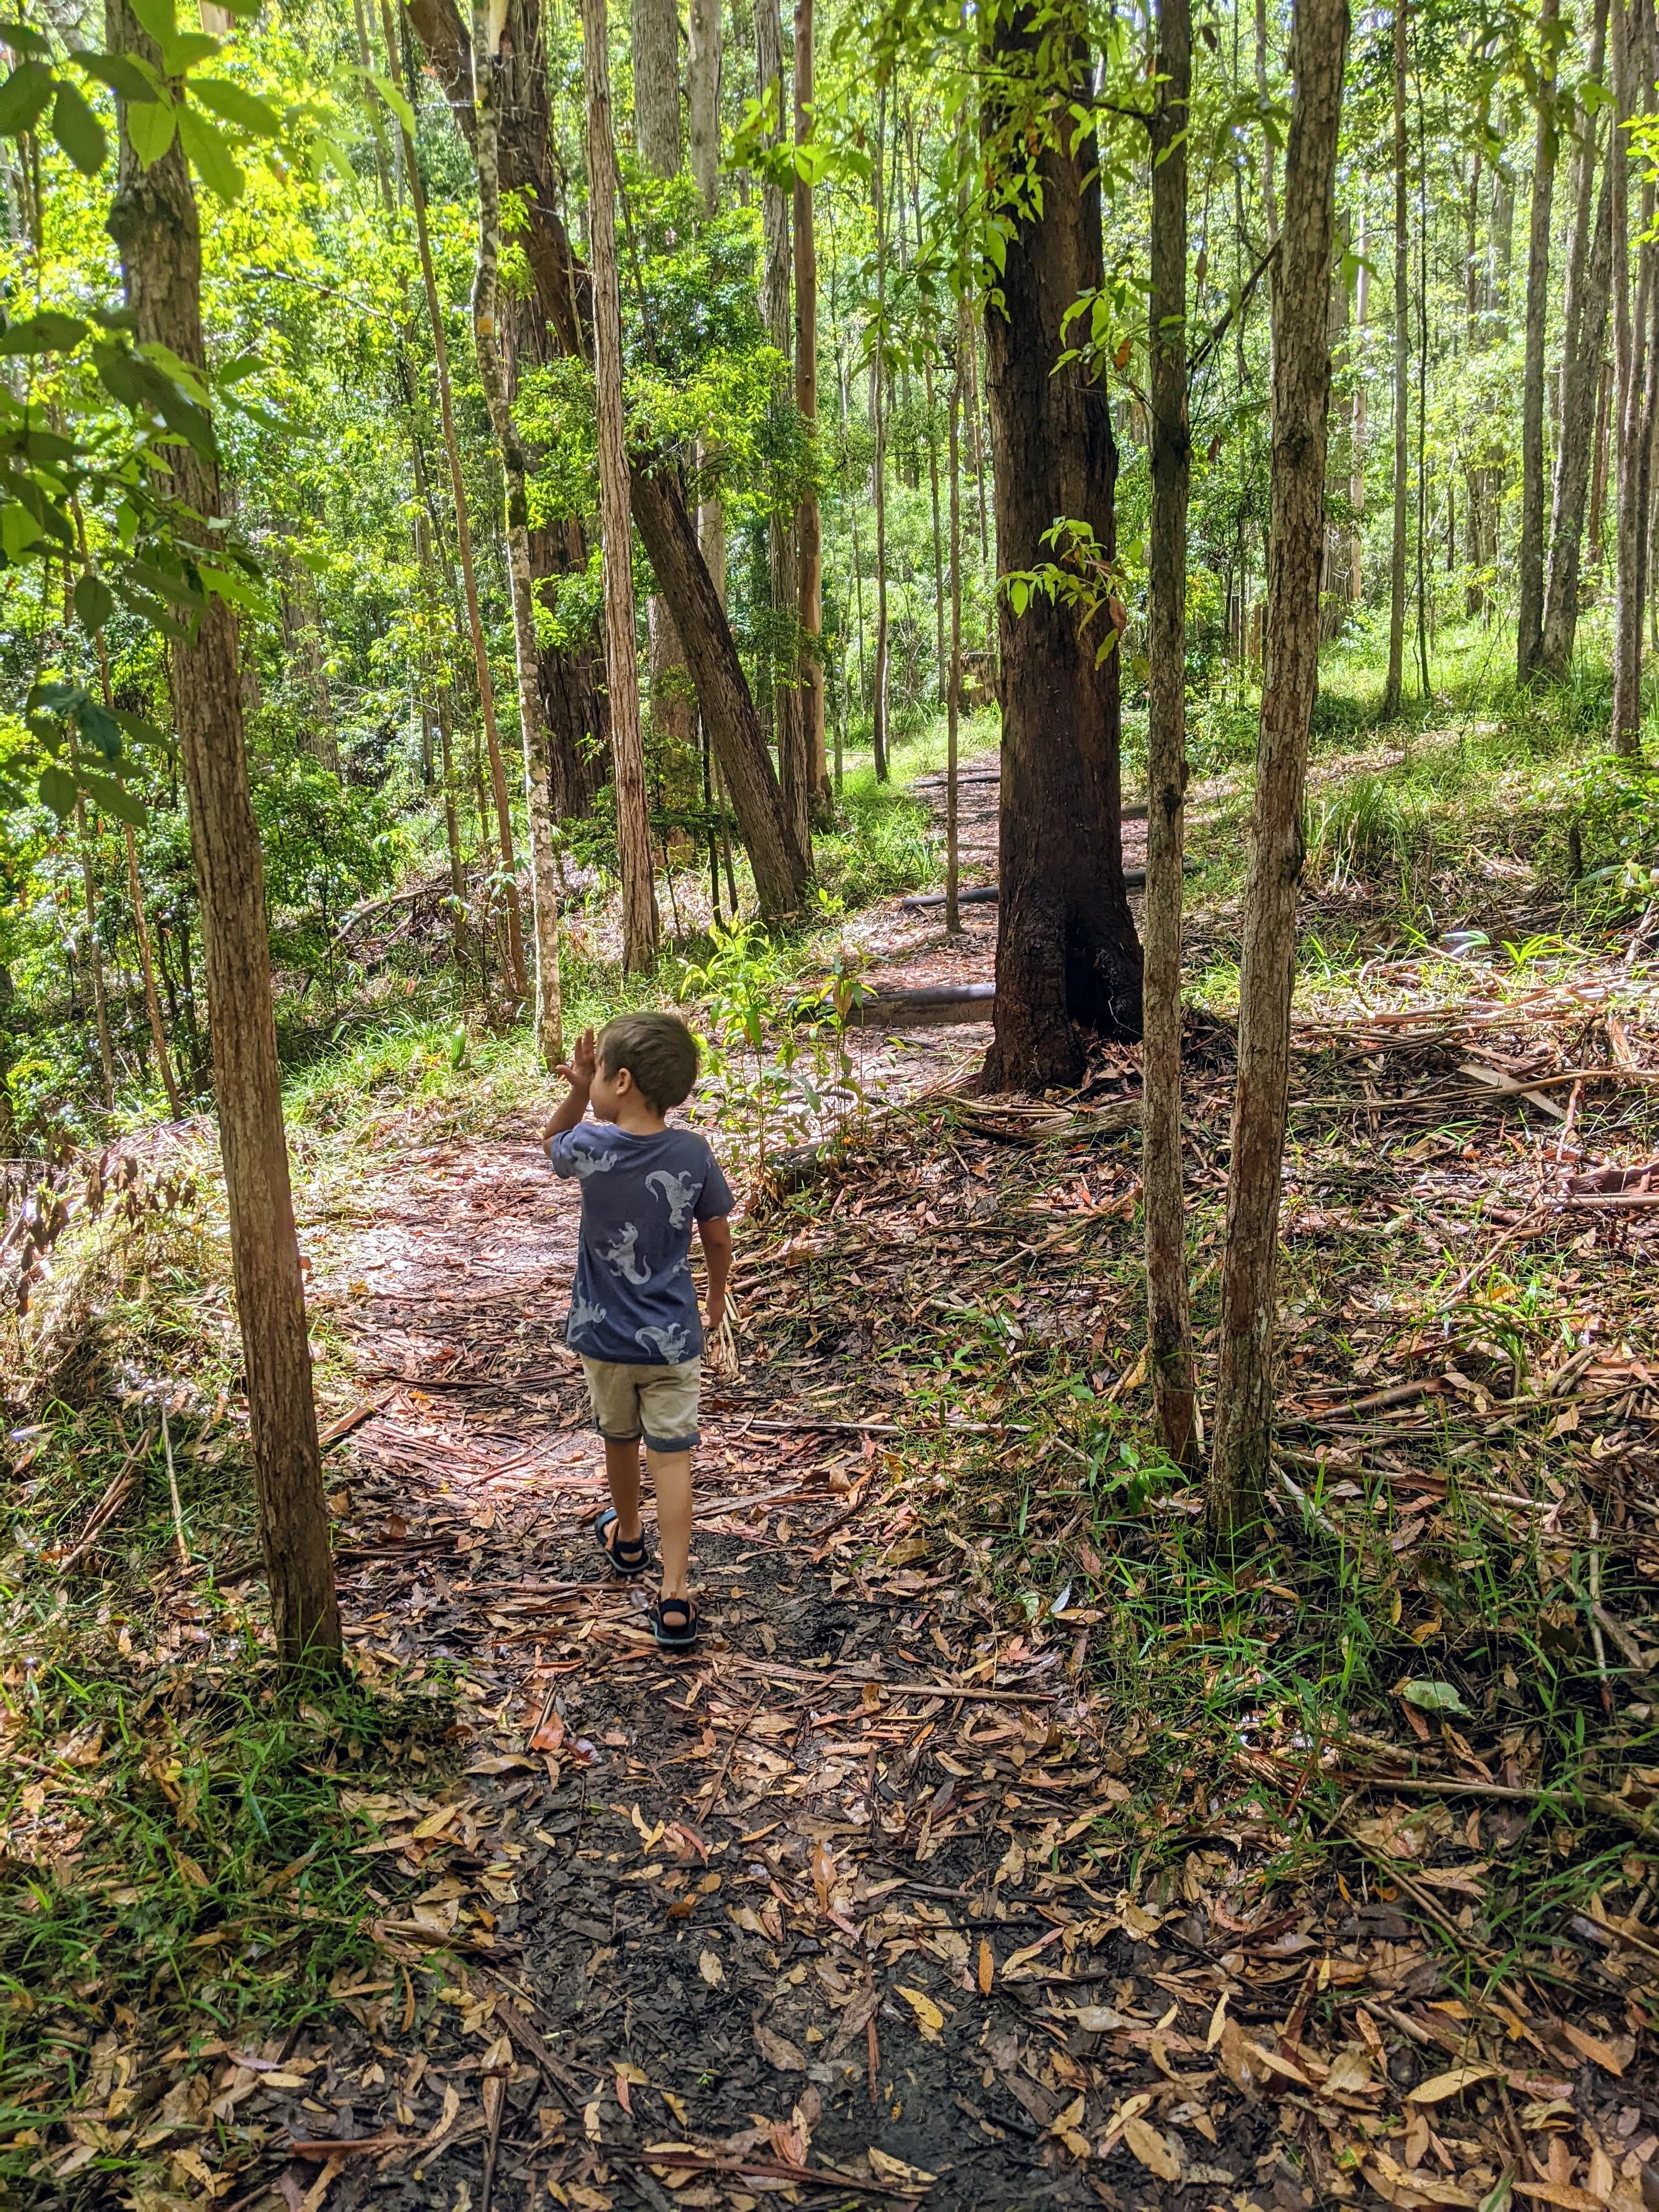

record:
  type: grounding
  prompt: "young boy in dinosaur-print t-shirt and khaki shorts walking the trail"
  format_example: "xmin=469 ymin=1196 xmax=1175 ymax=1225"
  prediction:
xmin=542 ymin=1013 xmax=732 ymax=1650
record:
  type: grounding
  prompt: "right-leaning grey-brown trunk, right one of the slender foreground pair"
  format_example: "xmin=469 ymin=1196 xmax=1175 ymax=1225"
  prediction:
xmin=1205 ymin=0 xmax=1353 ymax=1548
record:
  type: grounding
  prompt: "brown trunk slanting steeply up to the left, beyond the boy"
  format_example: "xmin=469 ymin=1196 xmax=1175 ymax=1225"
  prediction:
xmin=405 ymin=0 xmax=808 ymax=920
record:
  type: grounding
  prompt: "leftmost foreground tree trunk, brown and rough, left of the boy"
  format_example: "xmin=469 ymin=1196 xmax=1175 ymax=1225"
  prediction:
xmin=106 ymin=0 xmax=341 ymax=1674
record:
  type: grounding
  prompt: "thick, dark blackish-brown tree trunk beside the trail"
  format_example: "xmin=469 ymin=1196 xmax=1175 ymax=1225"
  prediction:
xmin=984 ymin=0 xmax=1142 ymax=1091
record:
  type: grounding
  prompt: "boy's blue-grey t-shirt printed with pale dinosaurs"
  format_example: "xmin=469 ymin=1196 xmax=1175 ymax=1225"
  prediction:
xmin=546 ymin=1121 xmax=732 ymax=1367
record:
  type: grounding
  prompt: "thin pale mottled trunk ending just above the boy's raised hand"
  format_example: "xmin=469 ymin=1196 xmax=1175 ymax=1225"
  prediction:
xmin=473 ymin=0 xmax=564 ymax=1070
